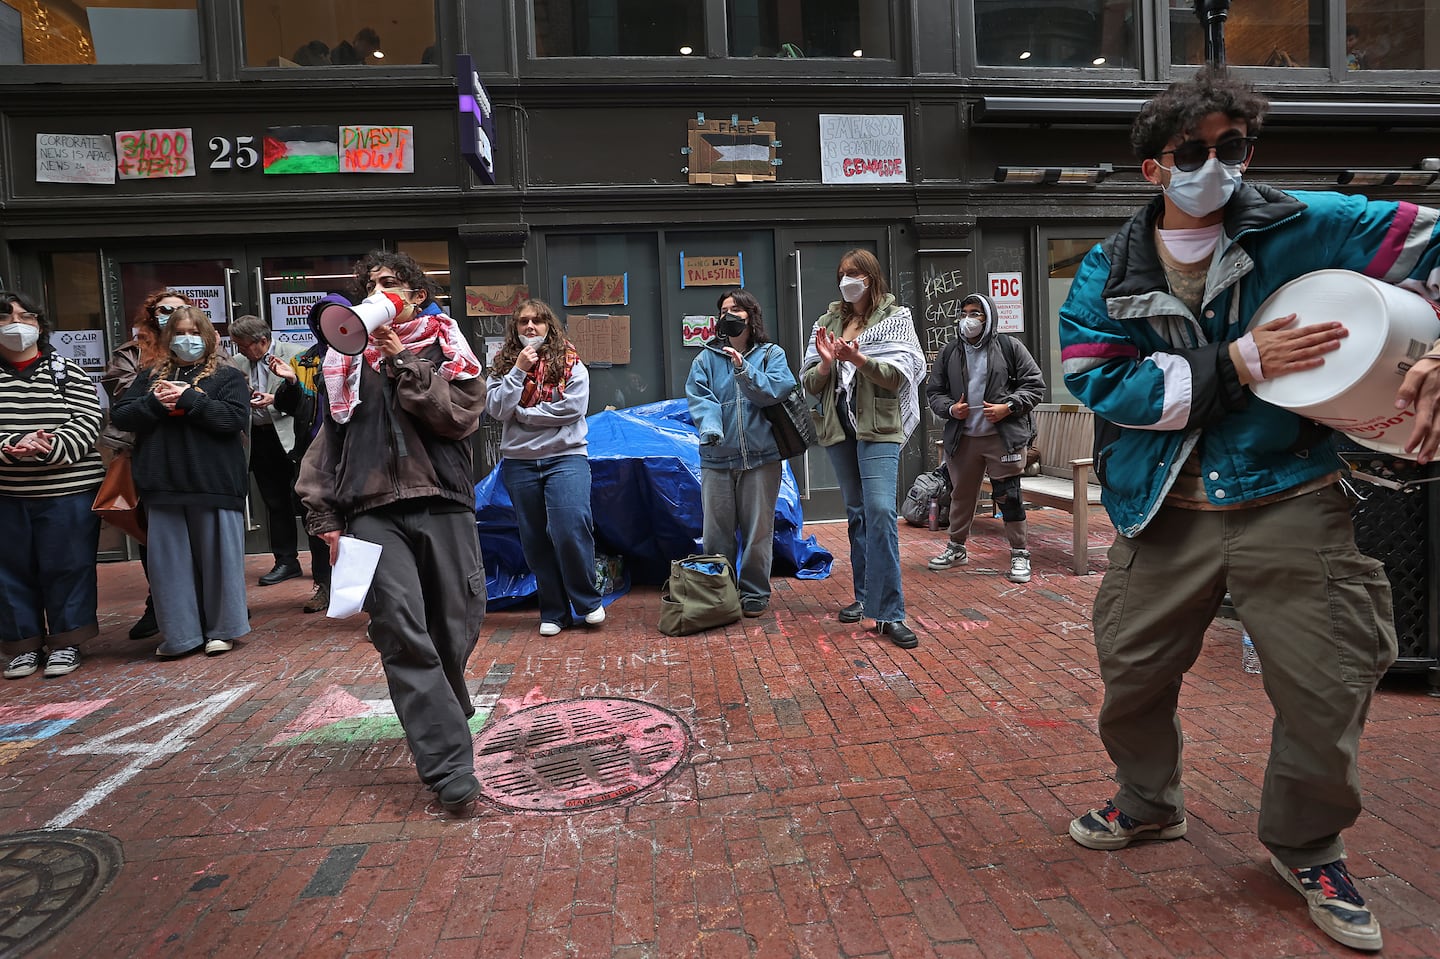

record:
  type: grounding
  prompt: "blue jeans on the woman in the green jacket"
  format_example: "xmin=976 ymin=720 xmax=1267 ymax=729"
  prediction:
xmin=825 ymin=439 xmax=904 ymax=622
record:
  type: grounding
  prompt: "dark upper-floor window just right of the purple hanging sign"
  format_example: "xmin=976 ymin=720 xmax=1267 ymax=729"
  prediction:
xmin=534 ymin=0 xmax=706 ymax=58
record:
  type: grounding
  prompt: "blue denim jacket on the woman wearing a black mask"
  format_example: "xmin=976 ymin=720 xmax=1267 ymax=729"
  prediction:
xmin=685 ymin=340 xmax=795 ymax=469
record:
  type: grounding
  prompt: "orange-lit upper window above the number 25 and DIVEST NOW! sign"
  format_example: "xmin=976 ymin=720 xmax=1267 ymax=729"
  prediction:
xmin=240 ymin=0 xmax=436 ymax=66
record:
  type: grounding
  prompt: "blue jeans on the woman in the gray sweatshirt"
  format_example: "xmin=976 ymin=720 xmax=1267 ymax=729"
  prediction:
xmin=501 ymin=455 xmax=600 ymax=626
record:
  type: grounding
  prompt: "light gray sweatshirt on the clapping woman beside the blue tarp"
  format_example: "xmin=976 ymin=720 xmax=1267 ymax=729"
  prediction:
xmin=485 ymin=360 xmax=590 ymax=459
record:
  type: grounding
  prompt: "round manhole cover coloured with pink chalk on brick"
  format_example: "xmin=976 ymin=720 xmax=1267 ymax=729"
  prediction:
xmin=475 ymin=698 xmax=690 ymax=812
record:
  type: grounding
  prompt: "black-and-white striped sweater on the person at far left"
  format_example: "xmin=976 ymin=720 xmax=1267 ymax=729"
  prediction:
xmin=0 ymin=348 xmax=105 ymax=497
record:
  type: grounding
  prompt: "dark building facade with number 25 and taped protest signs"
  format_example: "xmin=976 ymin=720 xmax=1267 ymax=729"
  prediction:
xmin=0 ymin=0 xmax=1440 ymax=544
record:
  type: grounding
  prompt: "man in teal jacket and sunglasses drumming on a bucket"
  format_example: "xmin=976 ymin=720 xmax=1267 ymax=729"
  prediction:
xmin=1060 ymin=68 xmax=1440 ymax=950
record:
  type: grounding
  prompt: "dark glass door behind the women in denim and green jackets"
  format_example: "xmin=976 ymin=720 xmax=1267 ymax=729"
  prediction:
xmin=776 ymin=228 xmax=894 ymax=523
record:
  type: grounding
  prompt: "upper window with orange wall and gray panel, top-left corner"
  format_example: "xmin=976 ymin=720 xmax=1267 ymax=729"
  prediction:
xmin=0 ymin=0 xmax=200 ymax=65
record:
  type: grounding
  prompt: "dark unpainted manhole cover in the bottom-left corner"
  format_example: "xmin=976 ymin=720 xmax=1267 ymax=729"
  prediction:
xmin=0 ymin=829 xmax=124 ymax=956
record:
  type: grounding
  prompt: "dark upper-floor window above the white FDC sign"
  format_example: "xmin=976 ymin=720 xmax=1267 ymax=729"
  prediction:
xmin=975 ymin=0 xmax=1134 ymax=69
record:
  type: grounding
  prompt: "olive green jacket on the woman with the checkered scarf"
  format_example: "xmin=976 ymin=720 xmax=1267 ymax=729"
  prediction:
xmin=801 ymin=294 xmax=910 ymax=446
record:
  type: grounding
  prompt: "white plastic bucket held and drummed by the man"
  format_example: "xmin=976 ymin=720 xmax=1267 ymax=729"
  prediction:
xmin=1251 ymin=269 xmax=1440 ymax=459
